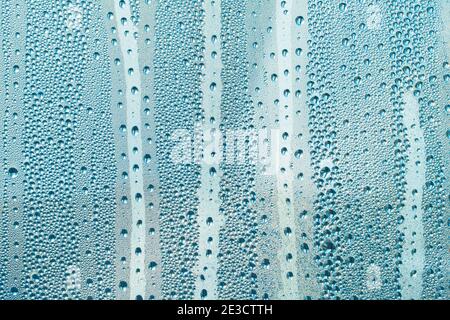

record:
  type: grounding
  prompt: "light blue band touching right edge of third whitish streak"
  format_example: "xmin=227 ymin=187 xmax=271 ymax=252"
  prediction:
xmin=291 ymin=0 xmax=320 ymax=299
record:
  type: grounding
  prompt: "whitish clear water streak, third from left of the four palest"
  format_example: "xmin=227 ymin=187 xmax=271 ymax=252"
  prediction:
xmin=275 ymin=1 xmax=299 ymax=299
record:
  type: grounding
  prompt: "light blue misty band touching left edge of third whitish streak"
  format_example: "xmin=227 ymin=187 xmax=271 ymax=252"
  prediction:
xmin=247 ymin=0 xmax=281 ymax=299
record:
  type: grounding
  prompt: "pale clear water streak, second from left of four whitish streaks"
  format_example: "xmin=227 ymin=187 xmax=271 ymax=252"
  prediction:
xmin=195 ymin=0 xmax=223 ymax=299
